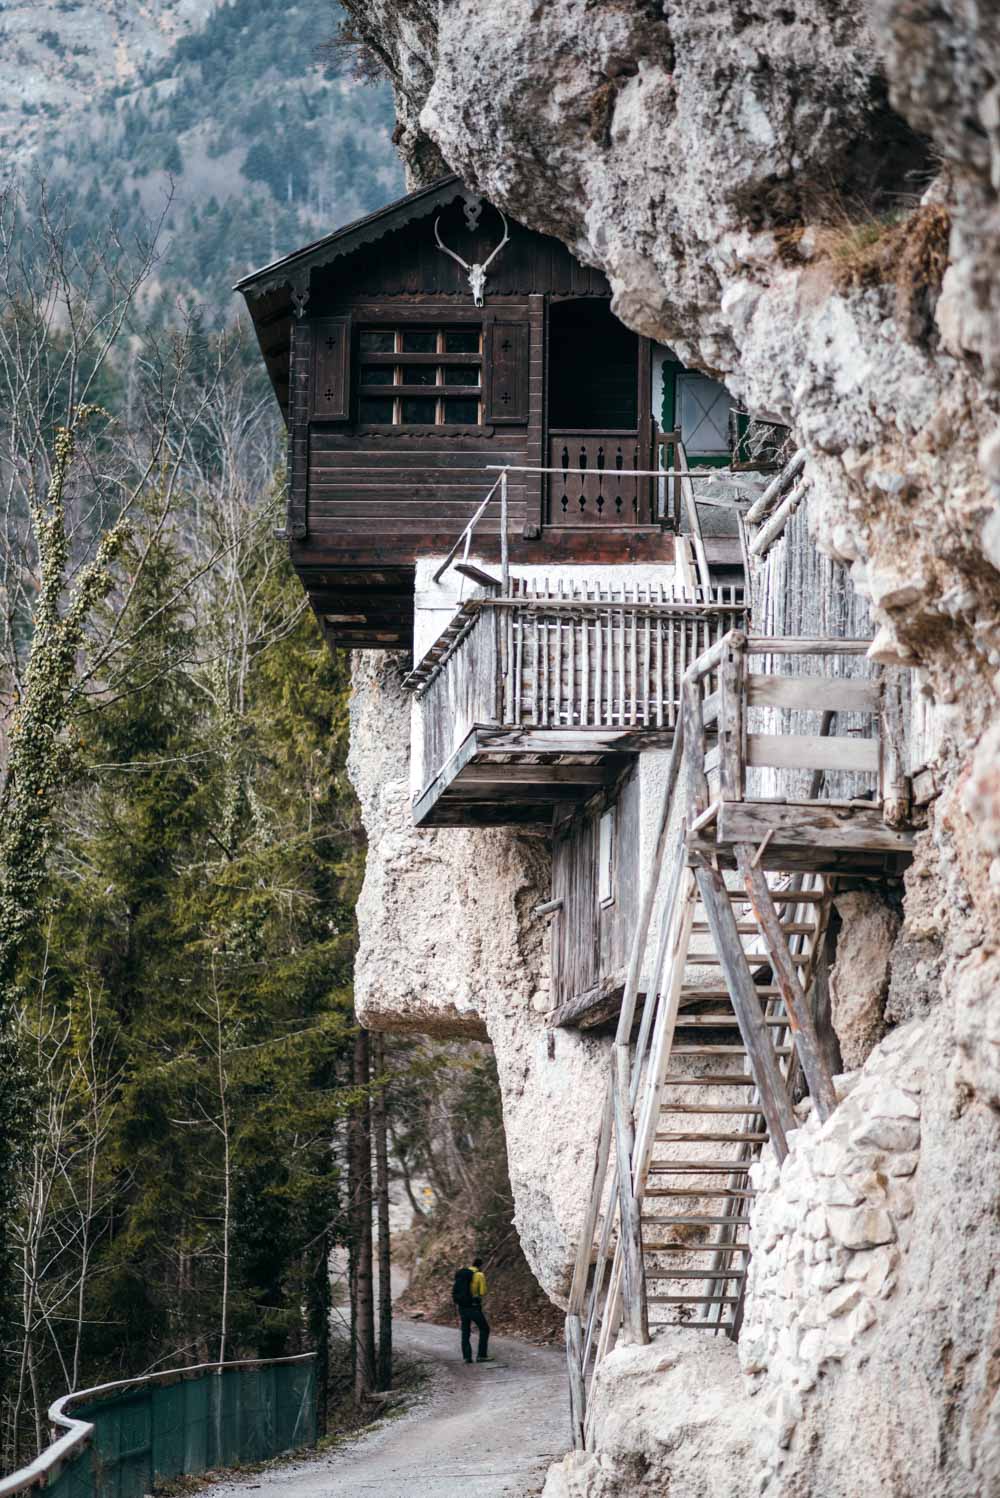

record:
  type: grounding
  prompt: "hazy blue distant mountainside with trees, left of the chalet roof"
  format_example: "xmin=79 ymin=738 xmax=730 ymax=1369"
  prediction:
xmin=0 ymin=0 xmax=403 ymax=321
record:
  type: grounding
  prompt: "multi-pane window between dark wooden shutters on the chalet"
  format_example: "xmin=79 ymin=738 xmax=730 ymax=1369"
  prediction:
xmin=358 ymin=328 xmax=482 ymax=427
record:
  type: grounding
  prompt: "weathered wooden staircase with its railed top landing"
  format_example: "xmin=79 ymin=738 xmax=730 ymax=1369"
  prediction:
xmin=566 ymin=631 xmax=912 ymax=1447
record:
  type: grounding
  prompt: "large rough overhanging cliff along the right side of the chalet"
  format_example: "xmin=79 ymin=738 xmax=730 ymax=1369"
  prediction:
xmin=344 ymin=0 xmax=1000 ymax=1498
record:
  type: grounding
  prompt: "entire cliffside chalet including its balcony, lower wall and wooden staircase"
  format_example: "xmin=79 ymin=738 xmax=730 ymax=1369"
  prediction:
xmin=240 ymin=177 xmax=915 ymax=1447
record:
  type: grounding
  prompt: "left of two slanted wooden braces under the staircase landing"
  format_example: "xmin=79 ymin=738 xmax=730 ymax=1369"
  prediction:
xmin=695 ymin=867 xmax=796 ymax=1164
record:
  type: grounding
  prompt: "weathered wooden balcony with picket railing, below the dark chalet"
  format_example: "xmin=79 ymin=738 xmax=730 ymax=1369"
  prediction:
xmin=406 ymin=584 xmax=744 ymax=827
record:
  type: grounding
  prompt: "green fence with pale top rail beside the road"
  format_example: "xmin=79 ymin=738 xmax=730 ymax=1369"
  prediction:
xmin=0 ymin=1353 xmax=316 ymax=1498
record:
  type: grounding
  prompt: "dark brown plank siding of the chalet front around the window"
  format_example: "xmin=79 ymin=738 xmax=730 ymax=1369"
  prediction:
xmin=281 ymin=204 xmax=672 ymax=646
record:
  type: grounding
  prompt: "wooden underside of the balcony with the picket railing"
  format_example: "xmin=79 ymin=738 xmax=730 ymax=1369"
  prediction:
xmin=413 ymin=724 xmax=672 ymax=827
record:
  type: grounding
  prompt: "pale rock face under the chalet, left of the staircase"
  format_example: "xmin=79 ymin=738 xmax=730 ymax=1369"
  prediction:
xmin=349 ymin=653 xmax=606 ymax=1302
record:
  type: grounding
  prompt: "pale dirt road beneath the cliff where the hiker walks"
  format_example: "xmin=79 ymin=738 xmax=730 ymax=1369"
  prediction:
xmin=197 ymin=1321 xmax=569 ymax=1498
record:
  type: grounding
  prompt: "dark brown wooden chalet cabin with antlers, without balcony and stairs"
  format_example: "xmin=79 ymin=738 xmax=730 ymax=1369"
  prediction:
xmin=238 ymin=177 xmax=738 ymax=649
